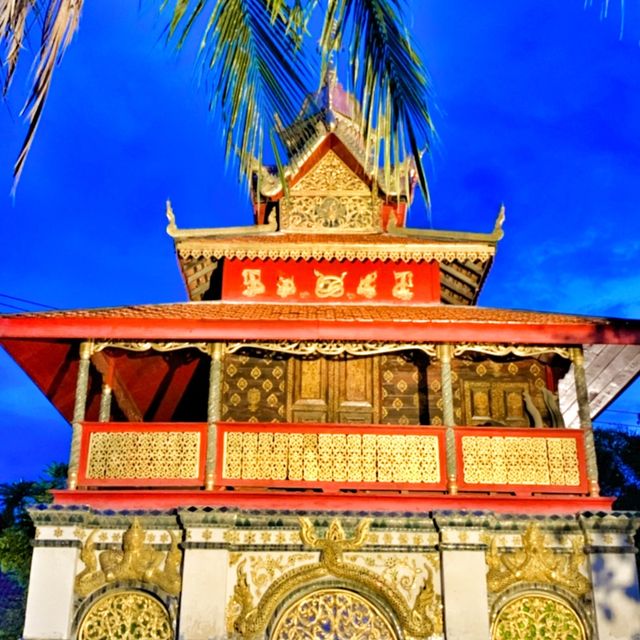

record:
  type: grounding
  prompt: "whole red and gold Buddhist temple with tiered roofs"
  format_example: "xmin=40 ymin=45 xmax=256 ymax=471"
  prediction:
xmin=0 ymin=74 xmax=640 ymax=640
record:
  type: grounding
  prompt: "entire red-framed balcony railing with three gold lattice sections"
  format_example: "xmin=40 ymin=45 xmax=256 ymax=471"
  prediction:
xmin=78 ymin=423 xmax=588 ymax=495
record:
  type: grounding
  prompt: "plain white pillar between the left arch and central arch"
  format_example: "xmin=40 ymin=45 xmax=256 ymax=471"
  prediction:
xmin=178 ymin=546 xmax=229 ymax=640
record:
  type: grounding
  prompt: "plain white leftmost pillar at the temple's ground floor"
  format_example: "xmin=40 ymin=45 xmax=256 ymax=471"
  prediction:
xmin=23 ymin=541 xmax=79 ymax=640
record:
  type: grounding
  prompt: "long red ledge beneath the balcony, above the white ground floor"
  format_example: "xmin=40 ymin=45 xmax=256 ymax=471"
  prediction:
xmin=52 ymin=490 xmax=615 ymax=515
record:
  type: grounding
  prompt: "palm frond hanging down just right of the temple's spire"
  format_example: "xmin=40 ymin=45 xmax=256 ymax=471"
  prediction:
xmin=321 ymin=0 xmax=433 ymax=203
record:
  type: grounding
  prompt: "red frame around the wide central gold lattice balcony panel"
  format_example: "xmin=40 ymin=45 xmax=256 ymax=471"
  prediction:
xmin=216 ymin=422 xmax=447 ymax=492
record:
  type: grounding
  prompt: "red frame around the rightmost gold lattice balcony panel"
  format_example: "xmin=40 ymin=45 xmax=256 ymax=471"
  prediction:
xmin=455 ymin=427 xmax=589 ymax=496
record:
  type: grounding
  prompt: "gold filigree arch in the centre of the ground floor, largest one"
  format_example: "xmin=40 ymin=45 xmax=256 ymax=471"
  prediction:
xmin=270 ymin=589 xmax=398 ymax=640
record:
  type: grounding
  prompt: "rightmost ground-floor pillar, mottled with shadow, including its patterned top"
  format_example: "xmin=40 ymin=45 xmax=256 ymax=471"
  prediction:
xmin=580 ymin=514 xmax=640 ymax=640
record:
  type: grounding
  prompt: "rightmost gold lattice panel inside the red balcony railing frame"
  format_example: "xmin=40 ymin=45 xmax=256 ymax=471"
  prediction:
xmin=461 ymin=436 xmax=580 ymax=487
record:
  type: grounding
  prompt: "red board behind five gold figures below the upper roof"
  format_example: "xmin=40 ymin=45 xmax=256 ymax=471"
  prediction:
xmin=222 ymin=258 xmax=440 ymax=305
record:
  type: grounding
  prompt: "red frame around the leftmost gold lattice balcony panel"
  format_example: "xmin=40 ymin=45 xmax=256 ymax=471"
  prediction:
xmin=78 ymin=422 xmax=207 ymax=488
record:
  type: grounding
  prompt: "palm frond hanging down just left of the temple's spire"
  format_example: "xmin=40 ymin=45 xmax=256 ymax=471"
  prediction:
xmin=169 ymin=0 xmax=309 ymax=175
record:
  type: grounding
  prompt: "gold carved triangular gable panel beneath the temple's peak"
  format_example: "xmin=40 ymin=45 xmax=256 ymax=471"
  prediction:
xmin=280 ymin=151 xmax=381 ymax=233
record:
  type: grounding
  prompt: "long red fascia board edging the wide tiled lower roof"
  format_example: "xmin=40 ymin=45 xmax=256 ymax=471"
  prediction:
xmin=0 ymin=316 xmax=640 ymax=345
